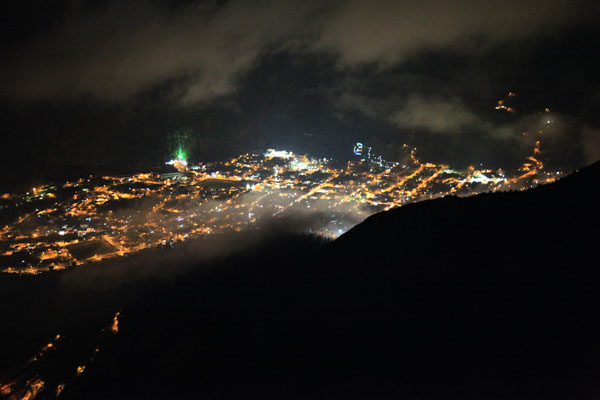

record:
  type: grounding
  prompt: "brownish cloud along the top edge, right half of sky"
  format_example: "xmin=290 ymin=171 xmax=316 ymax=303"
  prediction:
xmin=315 ymin=0 xmax=590 ymax=66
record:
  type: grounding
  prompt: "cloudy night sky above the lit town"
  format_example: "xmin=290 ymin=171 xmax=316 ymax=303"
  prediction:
xmin=0 ymin=0 xmax=600 ymax=189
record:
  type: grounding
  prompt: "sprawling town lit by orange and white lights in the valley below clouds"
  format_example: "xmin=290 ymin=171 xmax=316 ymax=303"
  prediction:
xmin=0 ymin=110 xmax=561 ymax=274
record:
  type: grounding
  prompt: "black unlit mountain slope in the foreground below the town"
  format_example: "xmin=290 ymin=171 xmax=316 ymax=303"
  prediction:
xmin=21 ymin=164 xmax=600 ymax=399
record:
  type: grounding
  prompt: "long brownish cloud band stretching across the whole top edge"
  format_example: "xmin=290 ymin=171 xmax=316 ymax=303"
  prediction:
xmin=0 ymin=0 xmax=590 ymax=104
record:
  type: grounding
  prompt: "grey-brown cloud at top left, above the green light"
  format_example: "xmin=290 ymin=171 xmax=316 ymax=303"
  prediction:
xmin=2 ymin=1 xmax=326 ymax=103
